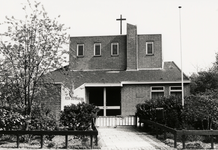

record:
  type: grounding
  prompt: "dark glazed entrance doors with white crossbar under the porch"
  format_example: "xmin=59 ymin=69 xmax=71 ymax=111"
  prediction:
xmin=87 ymin=87 xmax=121 ymax=116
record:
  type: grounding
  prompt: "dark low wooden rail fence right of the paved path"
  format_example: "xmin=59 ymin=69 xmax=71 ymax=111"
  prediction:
xmin=136 ymin=118 xmax=218 ymax=149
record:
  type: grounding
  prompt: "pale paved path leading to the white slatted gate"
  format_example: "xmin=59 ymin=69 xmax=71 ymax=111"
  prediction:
xmin=98 ymin=126 xmax=173 ymax=150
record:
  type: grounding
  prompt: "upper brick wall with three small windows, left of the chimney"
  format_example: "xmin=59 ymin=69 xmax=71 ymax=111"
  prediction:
xmin=70 ymin=35 xmax=126 ymax=70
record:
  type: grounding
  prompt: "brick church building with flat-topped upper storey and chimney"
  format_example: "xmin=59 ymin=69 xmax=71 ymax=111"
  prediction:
xmin=50 ymin=24 xmax=190 ymax=116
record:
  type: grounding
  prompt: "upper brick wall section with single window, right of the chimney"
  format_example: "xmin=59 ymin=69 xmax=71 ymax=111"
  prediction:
xmin=138 ymin=34 xmax=162 ymax=69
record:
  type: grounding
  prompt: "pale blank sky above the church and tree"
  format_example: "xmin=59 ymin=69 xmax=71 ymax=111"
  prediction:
xmin=0 ymin=0 xmax=218 ymax=75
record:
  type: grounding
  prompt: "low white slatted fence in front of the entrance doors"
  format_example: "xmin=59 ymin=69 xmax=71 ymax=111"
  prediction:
xmin=95 ymin=115 xmax=137 ymax=127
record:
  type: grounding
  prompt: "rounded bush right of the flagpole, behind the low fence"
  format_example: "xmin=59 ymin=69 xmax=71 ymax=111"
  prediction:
xmin=182 ymin=95 xmax=218 ymax=130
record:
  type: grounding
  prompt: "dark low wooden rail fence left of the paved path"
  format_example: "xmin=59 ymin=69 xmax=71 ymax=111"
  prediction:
xmin=0 ymin=120 xmax=98 ymax=148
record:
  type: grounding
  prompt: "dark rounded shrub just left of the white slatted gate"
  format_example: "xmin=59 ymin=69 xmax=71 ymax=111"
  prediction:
xmin=60 ymin=102 xmax=99 ymax=131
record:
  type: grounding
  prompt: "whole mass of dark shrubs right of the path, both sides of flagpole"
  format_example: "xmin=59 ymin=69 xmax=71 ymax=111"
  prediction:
xmin=136 ymin=95 xmax=218 ymax=130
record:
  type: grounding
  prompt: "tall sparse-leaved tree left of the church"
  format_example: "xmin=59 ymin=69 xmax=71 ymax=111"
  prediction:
xmin=0 ymin=1 xmax=68 ymax=115
